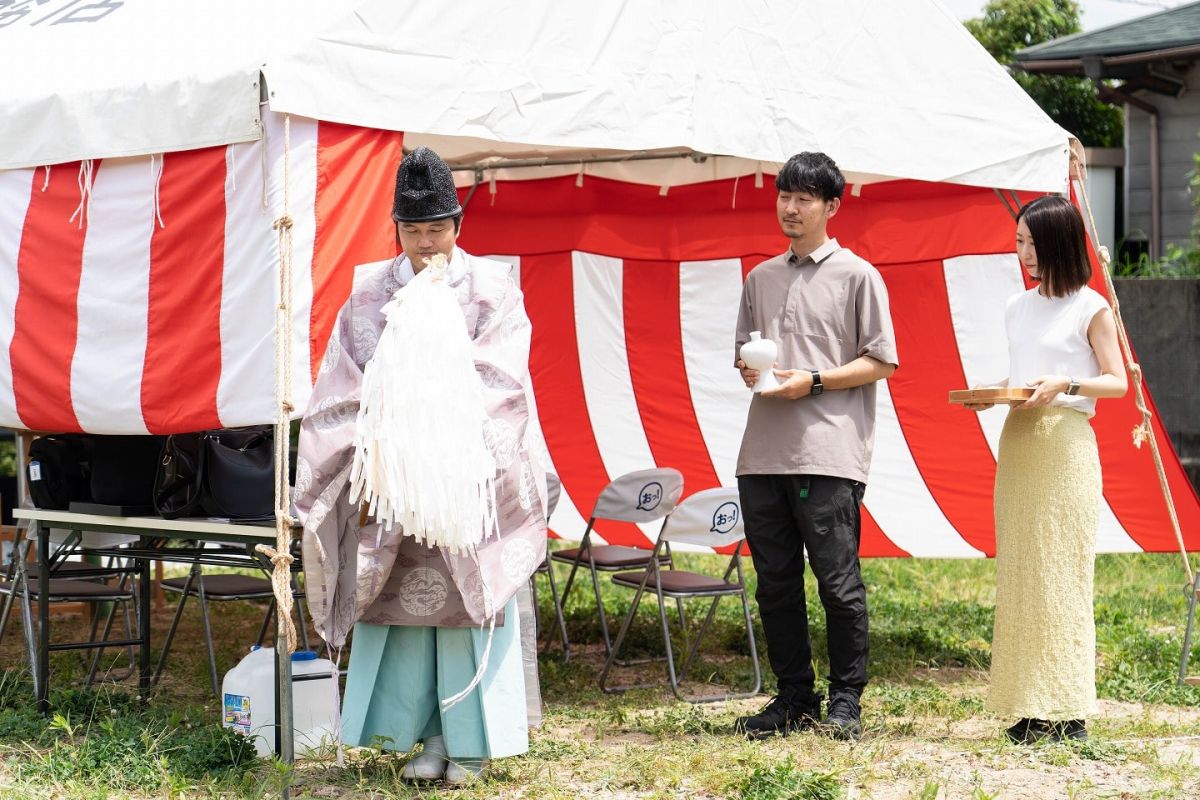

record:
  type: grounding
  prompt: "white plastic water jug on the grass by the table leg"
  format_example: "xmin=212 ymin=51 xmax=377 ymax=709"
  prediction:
xmin=221 ymin=646 xmax=338 ymax=756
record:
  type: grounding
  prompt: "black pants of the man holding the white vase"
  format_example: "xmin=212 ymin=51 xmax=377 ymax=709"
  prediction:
xmin=738 ymin=475 xmax=868 ymax=702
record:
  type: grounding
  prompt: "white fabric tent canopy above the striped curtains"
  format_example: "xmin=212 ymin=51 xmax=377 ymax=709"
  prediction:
xmin=0 ymin=0 xmax=1069 ymax=191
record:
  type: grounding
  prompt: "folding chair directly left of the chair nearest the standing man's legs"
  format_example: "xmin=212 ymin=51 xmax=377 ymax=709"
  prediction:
xmin=550 ymin=467 xmax=683 ymax=661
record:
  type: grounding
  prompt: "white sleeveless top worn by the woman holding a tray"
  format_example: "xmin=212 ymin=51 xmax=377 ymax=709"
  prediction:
xmin=1004 ymin=287 xmax=1109 ymax=416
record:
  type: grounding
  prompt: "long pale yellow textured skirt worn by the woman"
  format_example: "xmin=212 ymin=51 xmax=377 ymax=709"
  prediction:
xmin=988 ymin=407 xmax=1104 ymax=720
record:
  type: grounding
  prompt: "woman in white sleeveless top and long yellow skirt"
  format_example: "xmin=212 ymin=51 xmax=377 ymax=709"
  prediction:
xmin=967 ymin=197 xmax=1126 ymax=744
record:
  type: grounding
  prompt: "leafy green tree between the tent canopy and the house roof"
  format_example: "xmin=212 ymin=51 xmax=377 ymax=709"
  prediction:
xmin=965 ymin=0 xmax=1123 ymax=148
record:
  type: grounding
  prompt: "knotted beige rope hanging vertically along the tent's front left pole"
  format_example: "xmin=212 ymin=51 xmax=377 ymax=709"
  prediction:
xmin=256 ymin=115 xmax=296 ymax=654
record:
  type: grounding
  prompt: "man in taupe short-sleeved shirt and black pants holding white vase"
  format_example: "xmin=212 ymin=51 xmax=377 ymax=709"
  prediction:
xmin=734 ymin=152 xmax=899 ymax=739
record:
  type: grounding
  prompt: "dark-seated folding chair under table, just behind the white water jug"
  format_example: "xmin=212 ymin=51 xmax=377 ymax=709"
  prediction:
xmin=151 ymin=563 xmax=308 ymax=697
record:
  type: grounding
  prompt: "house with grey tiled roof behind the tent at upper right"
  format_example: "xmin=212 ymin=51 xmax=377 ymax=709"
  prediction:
xmin=1014 ymin=2 xmax=1200 ymax=258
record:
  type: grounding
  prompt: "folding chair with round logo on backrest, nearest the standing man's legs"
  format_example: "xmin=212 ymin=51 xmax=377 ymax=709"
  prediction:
xmin=600 ymin=488 xmax=762 ymax=703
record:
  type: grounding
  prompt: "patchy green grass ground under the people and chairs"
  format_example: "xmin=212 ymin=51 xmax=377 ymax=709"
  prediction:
xmin=0 ymin=555 xmax=1200 ymax=800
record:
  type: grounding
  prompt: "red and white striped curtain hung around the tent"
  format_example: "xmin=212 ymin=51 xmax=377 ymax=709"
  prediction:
xmin=0 ymin=115 xmax=1200 ymax=557
